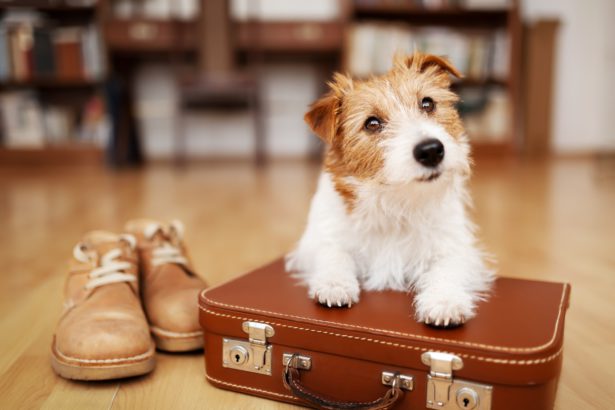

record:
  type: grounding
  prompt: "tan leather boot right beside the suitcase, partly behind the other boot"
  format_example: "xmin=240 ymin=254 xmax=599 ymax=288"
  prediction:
xmin=125 ymin=219 xmax=205 ymax=352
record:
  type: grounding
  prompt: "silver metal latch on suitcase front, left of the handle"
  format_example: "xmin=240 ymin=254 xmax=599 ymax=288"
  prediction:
xmin=222 ymin=321 xmax=275 ymax=376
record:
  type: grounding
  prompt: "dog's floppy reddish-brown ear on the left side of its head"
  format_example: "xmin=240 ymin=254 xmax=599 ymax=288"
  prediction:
xmin=303 ymin=73 xmax=352 ymax=144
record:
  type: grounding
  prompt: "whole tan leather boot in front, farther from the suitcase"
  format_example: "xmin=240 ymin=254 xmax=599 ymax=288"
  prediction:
xmin=51 ymin=231 xmax=155 ymax=380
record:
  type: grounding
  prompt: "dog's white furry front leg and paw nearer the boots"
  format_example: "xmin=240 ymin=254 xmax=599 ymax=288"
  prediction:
xmin=308 ymin=247 xmax=360 ymax=307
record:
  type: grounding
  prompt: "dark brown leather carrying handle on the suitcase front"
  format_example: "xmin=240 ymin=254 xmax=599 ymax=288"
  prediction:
xmin=282 ymin=353 xmax=403 ymax=410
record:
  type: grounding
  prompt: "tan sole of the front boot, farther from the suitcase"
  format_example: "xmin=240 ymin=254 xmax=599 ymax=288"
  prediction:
xmin=51 ymin=344 xmax=156 ymax=380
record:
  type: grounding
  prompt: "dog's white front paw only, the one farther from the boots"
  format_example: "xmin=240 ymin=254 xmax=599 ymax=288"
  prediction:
xmin=414 ymin=291 xmax=475 ymax=327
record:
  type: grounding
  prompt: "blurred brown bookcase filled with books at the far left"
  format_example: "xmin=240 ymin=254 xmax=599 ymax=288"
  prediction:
xmin=0 ymin=0 xmax=112 ymax=165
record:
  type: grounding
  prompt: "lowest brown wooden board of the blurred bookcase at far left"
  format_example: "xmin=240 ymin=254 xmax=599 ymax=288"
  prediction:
xmin=0 ymin=144 xmax=105 ymax=166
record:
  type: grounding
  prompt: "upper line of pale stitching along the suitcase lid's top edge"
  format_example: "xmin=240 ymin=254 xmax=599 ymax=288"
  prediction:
xmin=201 ymin=283 xmax=568 ymax=353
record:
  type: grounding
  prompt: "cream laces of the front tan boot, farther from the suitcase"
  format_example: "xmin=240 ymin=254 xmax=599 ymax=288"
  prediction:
xmin=73 ymin=235 xmax=137 ymax=290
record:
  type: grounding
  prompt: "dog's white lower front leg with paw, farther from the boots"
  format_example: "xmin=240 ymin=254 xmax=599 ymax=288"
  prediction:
xmin=414 ymin=251 xmax=490 ymax=326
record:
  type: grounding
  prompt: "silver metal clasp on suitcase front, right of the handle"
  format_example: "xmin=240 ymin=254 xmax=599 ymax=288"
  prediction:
xmin=421 ymin=352 xmax=493 ymax=410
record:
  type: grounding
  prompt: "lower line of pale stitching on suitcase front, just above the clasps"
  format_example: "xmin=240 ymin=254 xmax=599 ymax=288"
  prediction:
xmin=199 ymin=306 xmax=564 ymax=366
